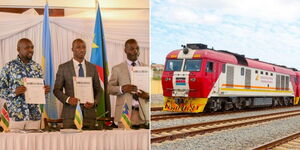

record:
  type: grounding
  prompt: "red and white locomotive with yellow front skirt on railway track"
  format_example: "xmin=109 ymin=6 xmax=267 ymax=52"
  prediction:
xmin=162 ymin=44 xmax=300 ymax=112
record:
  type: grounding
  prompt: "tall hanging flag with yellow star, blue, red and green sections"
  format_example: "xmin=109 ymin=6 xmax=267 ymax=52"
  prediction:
xmin=91 ymin=4 xmax=110 ymax=117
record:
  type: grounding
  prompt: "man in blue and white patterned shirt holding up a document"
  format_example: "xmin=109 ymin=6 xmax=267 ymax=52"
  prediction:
xmin=0 ymin=38 xmax=50 ymax=130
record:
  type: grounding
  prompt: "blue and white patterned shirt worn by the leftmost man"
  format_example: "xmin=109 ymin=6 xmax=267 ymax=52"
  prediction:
xmin=0 ymin=57 xmax=43 ymax=121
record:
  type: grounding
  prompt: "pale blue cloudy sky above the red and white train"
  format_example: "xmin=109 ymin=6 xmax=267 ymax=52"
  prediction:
xmin=151 ymin=0 xmax=300 ymax=70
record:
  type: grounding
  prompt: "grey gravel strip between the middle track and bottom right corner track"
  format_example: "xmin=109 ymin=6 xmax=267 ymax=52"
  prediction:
xmin=151 ymin=116 xmax=300 ymax=150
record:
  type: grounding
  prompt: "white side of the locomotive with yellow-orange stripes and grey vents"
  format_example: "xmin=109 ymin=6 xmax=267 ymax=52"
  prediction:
xmin=208 ymin=64 xmax=295 ymax=97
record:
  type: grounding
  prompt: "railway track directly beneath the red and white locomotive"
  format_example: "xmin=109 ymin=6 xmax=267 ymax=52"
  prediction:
xmin=151 ymin=105 xmax=300 ymax=121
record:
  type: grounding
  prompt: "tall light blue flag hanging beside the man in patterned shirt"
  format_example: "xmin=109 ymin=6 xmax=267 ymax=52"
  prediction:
xmin=40 ymin=3 xmax=58 ymax=121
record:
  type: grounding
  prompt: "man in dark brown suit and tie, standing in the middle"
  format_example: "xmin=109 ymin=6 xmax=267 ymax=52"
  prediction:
xmin=53 ymin=39 xmax=100 ymax=128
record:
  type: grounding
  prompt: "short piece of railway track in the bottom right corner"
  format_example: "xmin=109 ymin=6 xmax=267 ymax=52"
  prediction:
xmin=254 ymin=132 xmax=300 ymax=150
